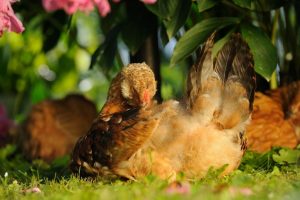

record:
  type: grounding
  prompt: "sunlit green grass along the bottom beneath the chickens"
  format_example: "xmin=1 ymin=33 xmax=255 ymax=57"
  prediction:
xmin=0 ymin=146 xmax=300 ymax=200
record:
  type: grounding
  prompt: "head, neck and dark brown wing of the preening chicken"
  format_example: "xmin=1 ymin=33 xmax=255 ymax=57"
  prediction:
xmin=70 ymin=63 xmax=158 ymax=176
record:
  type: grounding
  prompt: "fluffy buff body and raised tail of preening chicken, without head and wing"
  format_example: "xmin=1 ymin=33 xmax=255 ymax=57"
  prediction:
xmin=112 ymin=34 xmax=255 ymax=180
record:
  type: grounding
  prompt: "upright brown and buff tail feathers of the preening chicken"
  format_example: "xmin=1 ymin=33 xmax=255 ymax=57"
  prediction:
xmin=187 ymin=33 xmax=255 ymax=129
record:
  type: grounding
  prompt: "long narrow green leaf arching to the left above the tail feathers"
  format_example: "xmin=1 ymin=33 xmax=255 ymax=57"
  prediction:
xmin=171 ymin=17 xmax=240 ymax=65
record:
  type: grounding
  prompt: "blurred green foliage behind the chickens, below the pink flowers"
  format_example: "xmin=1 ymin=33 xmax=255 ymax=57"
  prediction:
xmin=0 ymin=0 xmax=300 ymax=121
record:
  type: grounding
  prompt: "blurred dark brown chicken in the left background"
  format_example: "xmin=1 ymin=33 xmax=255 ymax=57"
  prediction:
xmin=17 ymin=94 xmax=97 ymax=162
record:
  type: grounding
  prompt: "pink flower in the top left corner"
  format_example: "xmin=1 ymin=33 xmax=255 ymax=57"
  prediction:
xmin=0 ymin=0 xmax=24 ymax=36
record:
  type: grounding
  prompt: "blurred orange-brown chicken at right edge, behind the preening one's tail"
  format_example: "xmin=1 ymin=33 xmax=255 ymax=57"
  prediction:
xmin=246 ymin=82 xmax=300 ymax=152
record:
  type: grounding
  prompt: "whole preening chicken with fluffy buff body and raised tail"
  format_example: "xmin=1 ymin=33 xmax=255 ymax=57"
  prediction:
xmin=71 ymin=34 xmax=255 ymax=180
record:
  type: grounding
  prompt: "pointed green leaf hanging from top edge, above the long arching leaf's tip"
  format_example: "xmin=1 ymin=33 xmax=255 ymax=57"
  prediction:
xmin=162 ymin=1 xmax=192 ymax=39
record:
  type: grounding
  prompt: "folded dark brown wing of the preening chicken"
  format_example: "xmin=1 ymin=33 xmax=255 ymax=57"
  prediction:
xmin=71 ymin=108 xmax=158 ymax=176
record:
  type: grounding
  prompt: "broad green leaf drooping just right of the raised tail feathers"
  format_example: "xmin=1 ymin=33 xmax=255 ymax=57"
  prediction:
xmin=241 ymin=24 xmax=277 ymax=80
